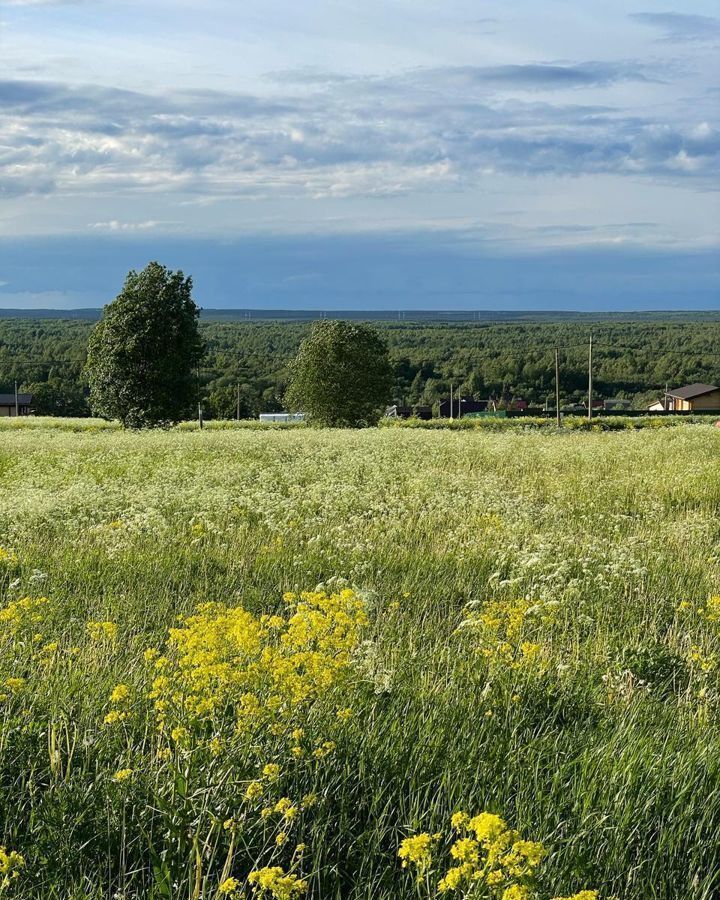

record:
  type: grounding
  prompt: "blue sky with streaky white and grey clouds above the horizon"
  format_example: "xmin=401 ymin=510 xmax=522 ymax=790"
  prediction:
xmin=0 ymin=0 xmax=720 ymax=310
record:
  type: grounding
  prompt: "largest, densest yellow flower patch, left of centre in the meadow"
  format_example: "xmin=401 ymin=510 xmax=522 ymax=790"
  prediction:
xmin=146 ymin=589 xmax=367 ymax=740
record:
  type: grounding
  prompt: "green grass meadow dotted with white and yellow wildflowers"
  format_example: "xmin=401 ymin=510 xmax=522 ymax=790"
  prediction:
xmin=0 ymin=425 xmax=720 ymax=900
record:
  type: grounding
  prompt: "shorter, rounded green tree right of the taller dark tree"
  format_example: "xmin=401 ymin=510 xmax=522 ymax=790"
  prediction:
xmin=285 ymin=320 xmax=393 ymax=428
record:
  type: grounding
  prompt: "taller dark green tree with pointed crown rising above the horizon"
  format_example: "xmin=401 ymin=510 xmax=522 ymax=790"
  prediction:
xmin=86 ymin=262 xmax=203 ymax=428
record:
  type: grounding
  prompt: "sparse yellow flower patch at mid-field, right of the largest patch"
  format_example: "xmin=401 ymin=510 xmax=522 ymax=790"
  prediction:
xmin=464 ymin=598 xmax=557 ymax=669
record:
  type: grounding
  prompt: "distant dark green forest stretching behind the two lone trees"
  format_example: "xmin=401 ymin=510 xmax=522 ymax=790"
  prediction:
xmin=0 ymin=313 xmax=720 ymax=418
